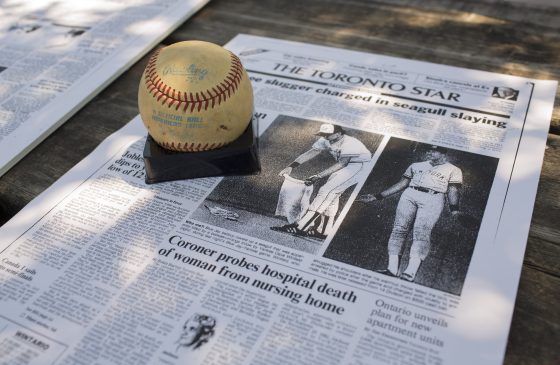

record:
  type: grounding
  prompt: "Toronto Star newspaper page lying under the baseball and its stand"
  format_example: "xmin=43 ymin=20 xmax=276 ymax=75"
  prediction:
xmin=0 ymin=35 xmax=556 ymax=365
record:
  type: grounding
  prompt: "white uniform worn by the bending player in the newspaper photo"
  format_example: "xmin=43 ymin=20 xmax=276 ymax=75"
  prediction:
xmin=309 ymin=134 xmax=371 ymax=214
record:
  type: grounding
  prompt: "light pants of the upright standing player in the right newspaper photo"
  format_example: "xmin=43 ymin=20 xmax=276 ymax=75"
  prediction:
xmin=388 ymin=188 xmax=445 ymax=260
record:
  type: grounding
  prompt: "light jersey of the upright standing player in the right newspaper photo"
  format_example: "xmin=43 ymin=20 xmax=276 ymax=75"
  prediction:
xmin=404 ymin=161 xmax=463 ymax=193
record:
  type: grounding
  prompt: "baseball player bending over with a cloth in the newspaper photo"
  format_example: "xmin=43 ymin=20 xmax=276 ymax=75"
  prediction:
xmin=270 ymin=123 xmax=371 ymax=239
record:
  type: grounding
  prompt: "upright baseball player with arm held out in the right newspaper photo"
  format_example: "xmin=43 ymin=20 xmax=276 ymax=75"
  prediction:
xmin=357 ymin=146 xmax=463 ymax=282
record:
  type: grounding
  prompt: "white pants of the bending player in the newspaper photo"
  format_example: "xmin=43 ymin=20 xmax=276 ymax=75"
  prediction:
xmin=309 ymin=162 xmax=364 ymax=214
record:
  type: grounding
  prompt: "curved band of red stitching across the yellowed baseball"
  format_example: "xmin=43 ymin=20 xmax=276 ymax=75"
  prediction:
xmin=145 ymin=50 xmax=243 ymax=112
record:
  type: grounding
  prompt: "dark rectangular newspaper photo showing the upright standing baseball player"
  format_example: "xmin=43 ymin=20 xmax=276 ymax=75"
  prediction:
xmin=323 ymin=138 xmax=498 ymax=295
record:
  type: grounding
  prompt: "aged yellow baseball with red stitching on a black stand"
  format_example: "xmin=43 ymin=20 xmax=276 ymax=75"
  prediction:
xmin=138 ymin=41 xmax=253 ymax=152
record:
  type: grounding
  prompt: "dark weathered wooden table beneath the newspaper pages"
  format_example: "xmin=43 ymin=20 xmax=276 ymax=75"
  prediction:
xmin=0 ymin=0 xmax=560 ymax=365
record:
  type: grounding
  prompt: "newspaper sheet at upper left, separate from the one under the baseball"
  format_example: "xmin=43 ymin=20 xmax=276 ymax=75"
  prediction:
xmin=0 ymin=0 xmax=208 ymax=175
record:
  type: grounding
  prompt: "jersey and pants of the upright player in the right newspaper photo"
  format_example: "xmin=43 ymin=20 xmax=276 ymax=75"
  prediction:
xmin=388 ymin=161 xmax=463 ymax=260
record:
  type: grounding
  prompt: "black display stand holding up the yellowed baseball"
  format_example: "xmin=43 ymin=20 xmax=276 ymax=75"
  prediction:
xmin=144 ymin=118 xmax=261 ymax=184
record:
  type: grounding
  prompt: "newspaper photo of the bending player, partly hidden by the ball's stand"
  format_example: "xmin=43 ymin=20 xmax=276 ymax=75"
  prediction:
xmin=191 ymin=116 xmax=383 ymax=254
